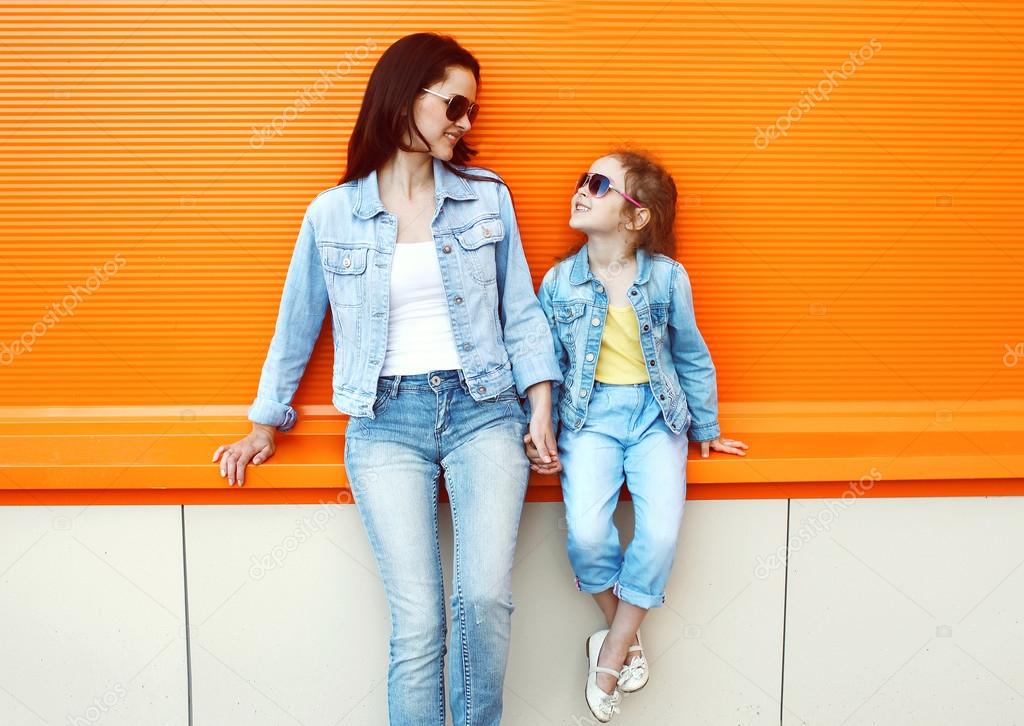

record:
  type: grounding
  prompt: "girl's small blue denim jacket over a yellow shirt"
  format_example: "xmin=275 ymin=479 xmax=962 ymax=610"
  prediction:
xmin=540 ymin=245 xmax=720 ymax=441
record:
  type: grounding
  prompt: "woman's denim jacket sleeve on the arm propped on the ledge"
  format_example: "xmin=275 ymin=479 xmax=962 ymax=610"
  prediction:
xmin=248 ymin=207 xmax=328 ymax=431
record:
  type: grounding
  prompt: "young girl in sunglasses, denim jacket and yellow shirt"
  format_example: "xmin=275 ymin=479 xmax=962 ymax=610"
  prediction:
xmin=523 ymin=151 xmax=746 ymax=723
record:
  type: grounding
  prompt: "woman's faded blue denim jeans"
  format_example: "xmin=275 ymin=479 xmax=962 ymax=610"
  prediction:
xmin=345 ymin=370 xmax=529 ymax=726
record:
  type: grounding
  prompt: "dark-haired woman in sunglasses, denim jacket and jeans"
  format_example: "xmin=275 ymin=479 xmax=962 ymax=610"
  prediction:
xmin=214 ymin=33 xmax=561 ymax=726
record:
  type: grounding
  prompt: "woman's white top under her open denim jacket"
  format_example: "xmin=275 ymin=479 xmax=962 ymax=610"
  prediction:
xmin=379 ymin=240 xmax=462 ymax=376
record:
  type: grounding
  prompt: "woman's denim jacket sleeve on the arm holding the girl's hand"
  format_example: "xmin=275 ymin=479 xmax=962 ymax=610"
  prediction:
xmin=495 ymin=183 xmax=562 ymax=396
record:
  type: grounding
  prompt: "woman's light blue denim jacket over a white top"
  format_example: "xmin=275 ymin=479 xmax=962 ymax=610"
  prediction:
xmin=248 ymin=159 xmax=561 ymax=431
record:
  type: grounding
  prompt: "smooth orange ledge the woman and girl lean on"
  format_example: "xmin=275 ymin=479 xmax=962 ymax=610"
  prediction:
xmin=0 ymin=399 xmax=1024 ymax=505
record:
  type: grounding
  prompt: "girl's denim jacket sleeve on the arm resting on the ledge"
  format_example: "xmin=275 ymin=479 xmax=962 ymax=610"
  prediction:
xmin=669 ymin=265 xmax=721 ymax=441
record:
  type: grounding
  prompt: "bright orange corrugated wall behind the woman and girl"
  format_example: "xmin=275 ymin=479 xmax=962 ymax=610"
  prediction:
xmin=0 ymin=0 xmax=1024 ymax=413
